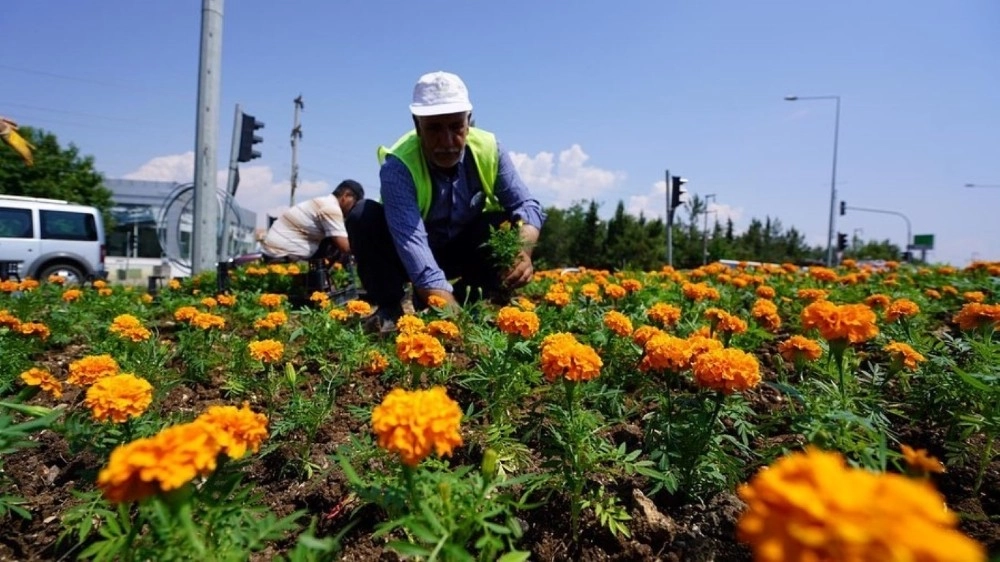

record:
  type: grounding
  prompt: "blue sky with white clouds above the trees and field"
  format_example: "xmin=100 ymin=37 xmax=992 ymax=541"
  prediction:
xmin=0 ymin=0 xmax=1000 ymax=265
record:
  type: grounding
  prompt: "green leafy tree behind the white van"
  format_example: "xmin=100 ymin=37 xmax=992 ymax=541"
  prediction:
xmin=0 ymin=127 xmax=112 ymax=212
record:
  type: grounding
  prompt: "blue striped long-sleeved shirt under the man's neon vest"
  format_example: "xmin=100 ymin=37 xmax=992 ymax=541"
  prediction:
xmin=379 ymin=140 xmax=545 ymax=291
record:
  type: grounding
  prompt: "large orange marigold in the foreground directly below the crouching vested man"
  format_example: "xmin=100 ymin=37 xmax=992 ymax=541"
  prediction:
xmin=372 ymin=386 xmax=462 ymax=467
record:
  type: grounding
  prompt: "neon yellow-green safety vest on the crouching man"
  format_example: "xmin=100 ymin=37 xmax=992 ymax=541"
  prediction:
xmin=378 ymin=127 xmax=502 ymax=218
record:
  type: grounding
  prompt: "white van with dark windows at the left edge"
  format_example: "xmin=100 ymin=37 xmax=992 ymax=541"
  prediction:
xmin=0 ymin=195 xmax=107 ymax=283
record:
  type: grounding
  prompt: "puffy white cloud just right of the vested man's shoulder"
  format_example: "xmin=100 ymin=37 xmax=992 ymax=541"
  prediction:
xmin=510 ymin=144 xmax=625 ymax=207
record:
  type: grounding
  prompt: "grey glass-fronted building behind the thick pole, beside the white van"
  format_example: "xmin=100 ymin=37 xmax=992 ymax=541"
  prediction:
xmin=104 ymin=179 xmax=257 ymax=282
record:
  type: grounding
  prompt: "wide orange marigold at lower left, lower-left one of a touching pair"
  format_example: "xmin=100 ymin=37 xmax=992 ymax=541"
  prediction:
xmin=97 ymin=422 xmax=220 ymax=503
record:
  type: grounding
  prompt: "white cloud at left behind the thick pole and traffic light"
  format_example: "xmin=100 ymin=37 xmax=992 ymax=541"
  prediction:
xmin=124 ymin=152 xmax=332 ymax=225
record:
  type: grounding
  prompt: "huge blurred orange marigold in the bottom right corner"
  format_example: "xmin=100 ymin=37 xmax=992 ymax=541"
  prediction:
xmin=737 ymin=448 xmax=986 ymax=562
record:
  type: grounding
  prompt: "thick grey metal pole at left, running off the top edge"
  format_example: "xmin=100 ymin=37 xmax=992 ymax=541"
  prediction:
xmin=191 ymin=0 xmax=223 ymax=274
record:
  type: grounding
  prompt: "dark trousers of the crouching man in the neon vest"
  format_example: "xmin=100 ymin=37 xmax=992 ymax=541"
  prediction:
xmin=345 ymin=199 xmax=510 ymax=311
